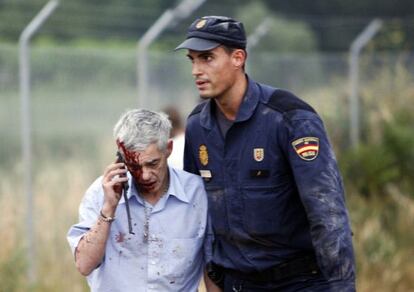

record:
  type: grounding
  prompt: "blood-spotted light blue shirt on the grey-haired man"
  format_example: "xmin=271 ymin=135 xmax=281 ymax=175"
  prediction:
xmin=67 ymin=168 xmax=207 ymax=292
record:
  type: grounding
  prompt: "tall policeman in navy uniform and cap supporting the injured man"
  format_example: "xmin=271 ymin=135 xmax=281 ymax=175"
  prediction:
xmin=176 ymin=16 xmax=355 ymax=292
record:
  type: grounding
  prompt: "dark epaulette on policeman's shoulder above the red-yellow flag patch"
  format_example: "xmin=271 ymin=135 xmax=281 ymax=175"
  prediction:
xmin=267 ymin=89 xmax=316 ymax=113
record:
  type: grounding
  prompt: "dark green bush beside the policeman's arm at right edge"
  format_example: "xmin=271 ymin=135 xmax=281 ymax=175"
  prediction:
xmin=340 ymin=111 xmax=414 ymax=197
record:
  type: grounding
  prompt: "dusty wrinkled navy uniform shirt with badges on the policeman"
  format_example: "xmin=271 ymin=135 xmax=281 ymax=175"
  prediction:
xmin=184 ymin=76 xmax=355 ymax=290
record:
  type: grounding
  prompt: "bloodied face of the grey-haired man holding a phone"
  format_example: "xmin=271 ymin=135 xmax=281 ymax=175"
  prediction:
xmin=120 ymin=140 xmax=172 ymax=195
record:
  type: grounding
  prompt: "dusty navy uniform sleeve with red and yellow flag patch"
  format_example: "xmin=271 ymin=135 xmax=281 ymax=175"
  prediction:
xmin=280 ymin=110 xmax=354 ymax=281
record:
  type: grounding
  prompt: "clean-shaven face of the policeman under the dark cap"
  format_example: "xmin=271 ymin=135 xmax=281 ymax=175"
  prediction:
xmin=187 ymin=46 xmax=244 ymax=98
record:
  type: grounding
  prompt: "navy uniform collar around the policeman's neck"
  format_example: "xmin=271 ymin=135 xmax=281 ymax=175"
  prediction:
xmin=200 ymin=74 xmax=260 ymax=129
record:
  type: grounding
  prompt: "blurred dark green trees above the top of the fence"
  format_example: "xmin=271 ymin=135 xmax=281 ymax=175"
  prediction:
xmin=0 ymin=0 xmax=414 ymax=51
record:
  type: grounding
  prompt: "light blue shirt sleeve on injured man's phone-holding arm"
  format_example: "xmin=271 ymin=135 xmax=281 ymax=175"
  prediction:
xmin=67 ymin=178 xmax=103 ymax=254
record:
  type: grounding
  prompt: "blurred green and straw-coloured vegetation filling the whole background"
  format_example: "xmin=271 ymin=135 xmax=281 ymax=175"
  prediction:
xmin=0 ymin=0 xmax=414 ymax=292
